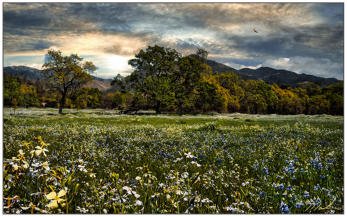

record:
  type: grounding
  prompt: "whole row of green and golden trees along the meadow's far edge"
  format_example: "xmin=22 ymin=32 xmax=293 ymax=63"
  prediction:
xmin=4 ymin=45 xmax=343 ymax=115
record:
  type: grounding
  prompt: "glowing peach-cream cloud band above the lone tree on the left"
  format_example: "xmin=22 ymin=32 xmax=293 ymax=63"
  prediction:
xmin=4 ymin=32 xmax=150 ymax=56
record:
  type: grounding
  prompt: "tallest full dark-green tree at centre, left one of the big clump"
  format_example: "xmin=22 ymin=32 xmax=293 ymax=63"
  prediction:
xmin=129 ymin=45 xmax=180 ymax=113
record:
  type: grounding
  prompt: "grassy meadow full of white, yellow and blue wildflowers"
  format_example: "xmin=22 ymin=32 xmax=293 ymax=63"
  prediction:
xmin=3 ymin=108 xmax=344 ymax=214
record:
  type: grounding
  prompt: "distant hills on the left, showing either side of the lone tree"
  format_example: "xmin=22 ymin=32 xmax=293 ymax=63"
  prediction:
xmin=4 ymin=66 xmax=112 ymax=91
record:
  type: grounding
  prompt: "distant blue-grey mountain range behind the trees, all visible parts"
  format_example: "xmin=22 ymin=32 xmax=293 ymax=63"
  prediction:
xmin=3 ymin=60 xmax=341 ymax=92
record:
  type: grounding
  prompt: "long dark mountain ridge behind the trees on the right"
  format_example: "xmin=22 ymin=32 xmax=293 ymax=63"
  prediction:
xmin=206 ymin=60 xmax=340 ymax=86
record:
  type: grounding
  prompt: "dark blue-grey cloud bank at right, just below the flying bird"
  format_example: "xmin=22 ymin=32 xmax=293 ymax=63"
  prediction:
xmin=219 ymin=22 xmax=344 ymax=63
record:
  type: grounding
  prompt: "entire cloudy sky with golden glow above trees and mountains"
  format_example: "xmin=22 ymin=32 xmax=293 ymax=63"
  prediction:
xmin=3 ymin=3 xmax=344 ymax=80
